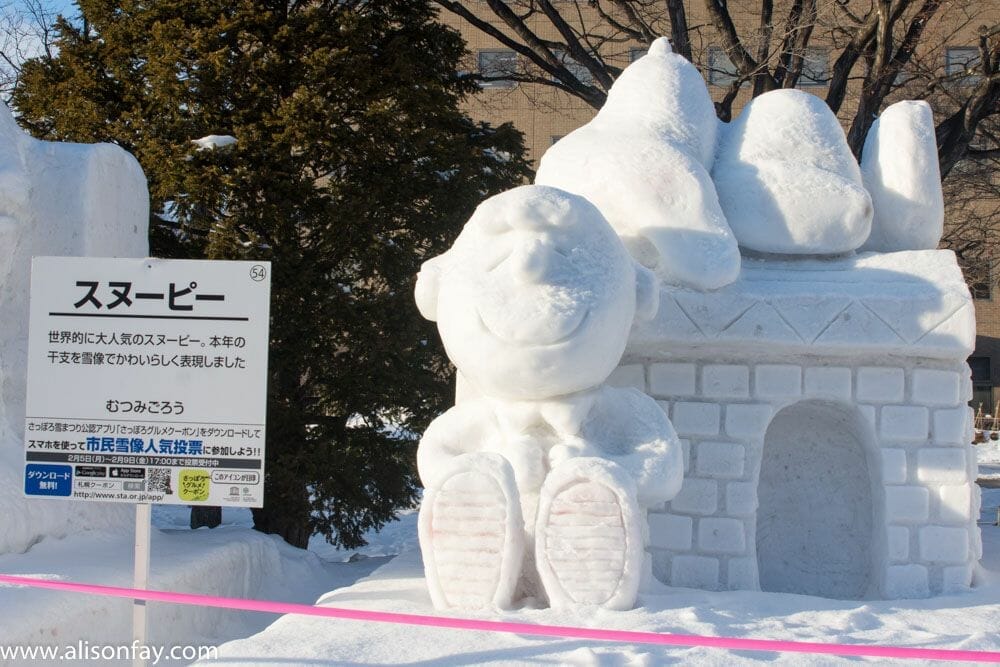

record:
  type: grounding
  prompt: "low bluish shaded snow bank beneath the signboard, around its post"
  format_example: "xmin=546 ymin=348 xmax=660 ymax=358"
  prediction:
xmin=0 ymin=506 xmax=386 ymax=664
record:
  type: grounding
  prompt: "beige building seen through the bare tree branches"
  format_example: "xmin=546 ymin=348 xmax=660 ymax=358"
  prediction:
xmin=441 ymin=0 xmax=1000 ymax=412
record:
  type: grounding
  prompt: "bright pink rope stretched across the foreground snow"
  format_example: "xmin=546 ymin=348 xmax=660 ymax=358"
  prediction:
xmin=0 ymin=575 xmax=1000 ymax=663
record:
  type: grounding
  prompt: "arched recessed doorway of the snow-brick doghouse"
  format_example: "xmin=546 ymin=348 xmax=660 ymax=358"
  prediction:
xmin=757 ymin=401 xmax=873 ymax=599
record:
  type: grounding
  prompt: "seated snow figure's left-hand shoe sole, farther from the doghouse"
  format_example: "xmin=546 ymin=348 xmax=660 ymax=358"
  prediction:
xmin=419 ymin=453 xmax=524 ymax=609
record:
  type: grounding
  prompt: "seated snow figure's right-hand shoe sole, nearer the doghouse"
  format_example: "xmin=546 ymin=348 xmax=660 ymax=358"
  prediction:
xmin=535 ymin=457 xmax=645 ymax=609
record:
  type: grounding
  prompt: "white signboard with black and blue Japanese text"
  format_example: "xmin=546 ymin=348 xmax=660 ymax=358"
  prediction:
xmin=24 ymin=257 xmax=271 ymax=507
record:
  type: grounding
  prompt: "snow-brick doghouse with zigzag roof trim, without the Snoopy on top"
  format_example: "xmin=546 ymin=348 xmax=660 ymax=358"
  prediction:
xmin=613 ymin=250 xmax=981 ymax=598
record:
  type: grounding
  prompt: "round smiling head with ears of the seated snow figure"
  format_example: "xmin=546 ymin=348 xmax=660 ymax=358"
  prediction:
xmin=416 ymin=185 xmax=658 ymax=400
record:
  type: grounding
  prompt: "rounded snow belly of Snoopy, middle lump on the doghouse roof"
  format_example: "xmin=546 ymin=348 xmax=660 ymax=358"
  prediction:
xmin=712 ymin=90 xmax=872 ymax=255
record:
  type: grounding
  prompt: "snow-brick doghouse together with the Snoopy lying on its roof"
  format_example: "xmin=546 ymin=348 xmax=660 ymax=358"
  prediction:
xmin=539 ymin=39 xmax=981 ymax=598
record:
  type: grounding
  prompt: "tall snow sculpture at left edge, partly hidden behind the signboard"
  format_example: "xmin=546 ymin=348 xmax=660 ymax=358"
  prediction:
xmin=0 ymin=105 xmax=149 ymax=554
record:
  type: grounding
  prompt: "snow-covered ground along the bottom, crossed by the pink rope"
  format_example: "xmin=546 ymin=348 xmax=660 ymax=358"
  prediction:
xmin=0 ymin=489 xmax=1000 ymax=665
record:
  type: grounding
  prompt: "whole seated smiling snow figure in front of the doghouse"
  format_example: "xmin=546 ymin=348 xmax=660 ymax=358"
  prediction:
xmin=416 ymin=186 xmax=682 ymax=609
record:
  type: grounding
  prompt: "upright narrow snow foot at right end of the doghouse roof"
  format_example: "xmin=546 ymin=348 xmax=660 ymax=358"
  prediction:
xmin=861 ymin=101 xmax=944 ymax=252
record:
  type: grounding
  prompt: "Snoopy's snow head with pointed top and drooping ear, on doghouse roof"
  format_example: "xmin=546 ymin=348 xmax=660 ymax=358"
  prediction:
xmin=535 ymin=37 xmax=740 ymax=289
